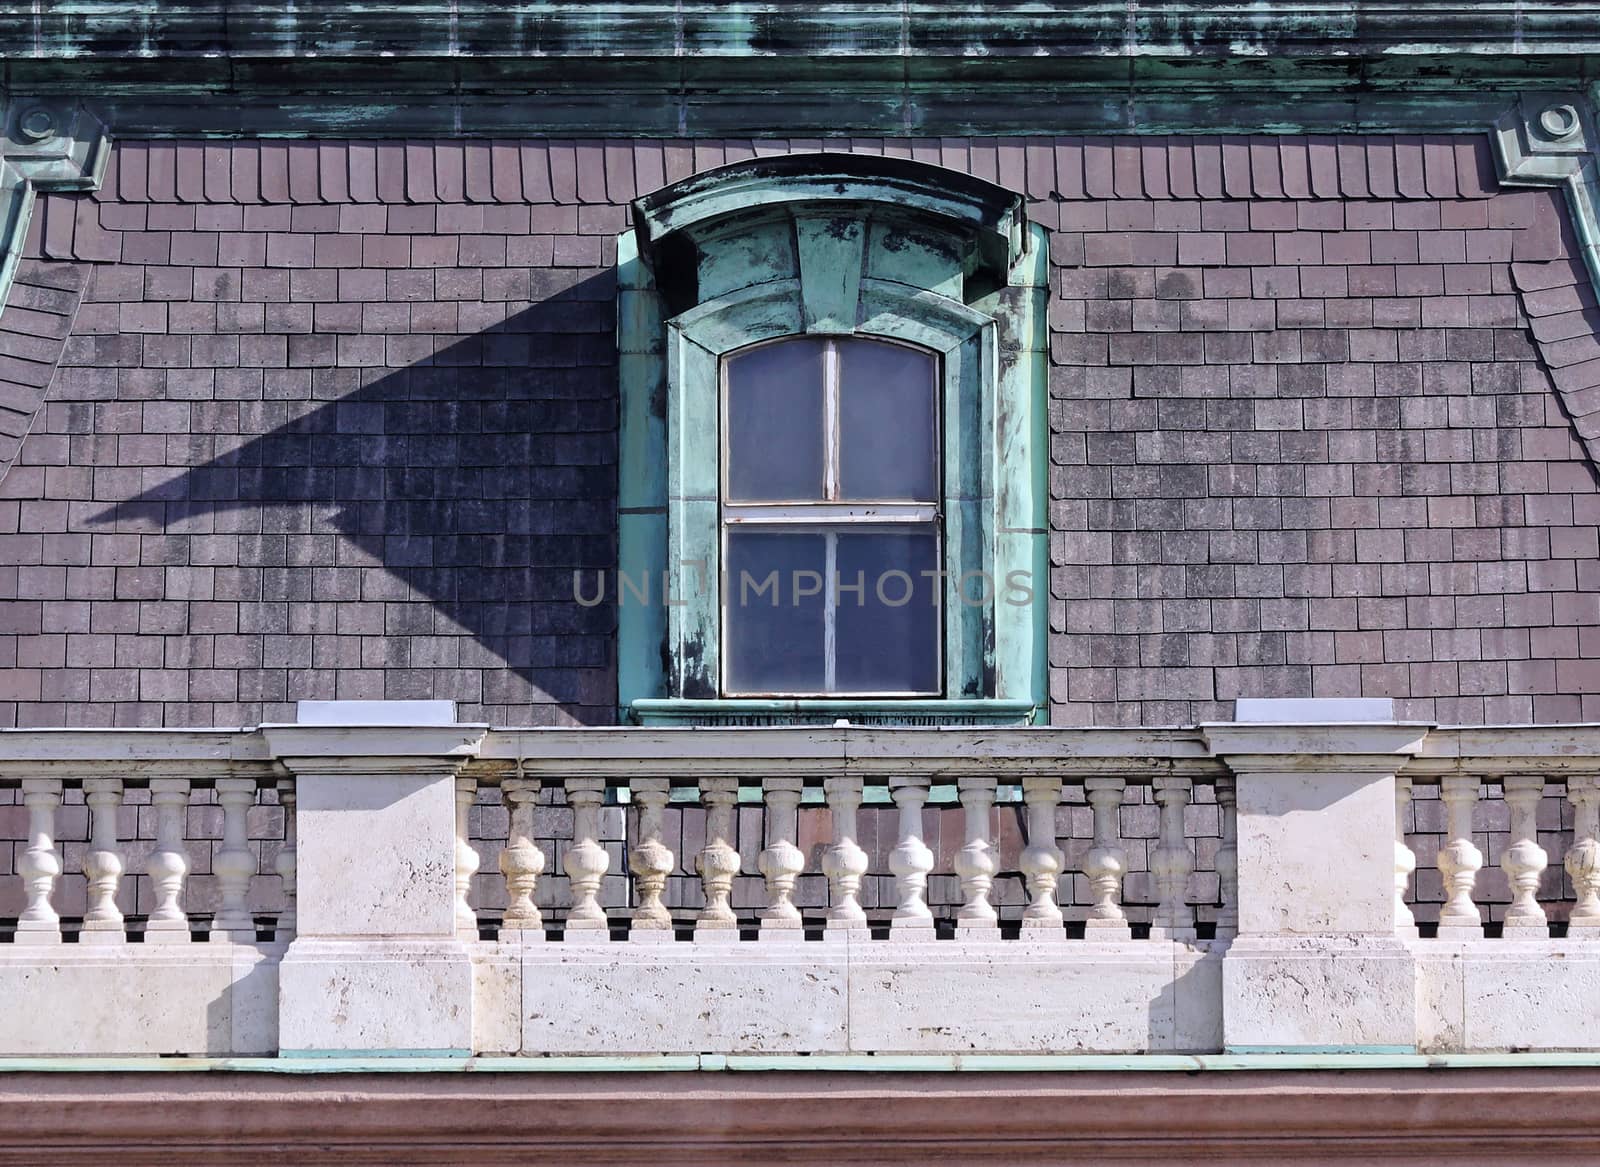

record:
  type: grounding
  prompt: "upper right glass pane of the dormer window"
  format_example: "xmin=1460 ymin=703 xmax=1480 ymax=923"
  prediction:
xmin=838 ymin=339 xmax=939 ymax=503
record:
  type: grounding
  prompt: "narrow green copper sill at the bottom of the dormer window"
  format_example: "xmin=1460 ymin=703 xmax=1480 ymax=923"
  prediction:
xmin=629 ymin=698 xmax=1037 ymax=725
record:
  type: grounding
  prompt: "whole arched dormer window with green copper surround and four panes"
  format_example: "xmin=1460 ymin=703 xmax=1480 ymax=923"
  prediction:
xmin=618 ymin=154 xmax=1048 ymax=724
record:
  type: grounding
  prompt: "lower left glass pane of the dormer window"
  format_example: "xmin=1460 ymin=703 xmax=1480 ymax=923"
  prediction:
xmin=723 ymin=530 xmax=827 ymax=693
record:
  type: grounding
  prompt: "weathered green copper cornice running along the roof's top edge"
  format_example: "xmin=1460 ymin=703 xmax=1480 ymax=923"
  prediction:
xmin=0 ymin=0 xmax=1600 ymax=136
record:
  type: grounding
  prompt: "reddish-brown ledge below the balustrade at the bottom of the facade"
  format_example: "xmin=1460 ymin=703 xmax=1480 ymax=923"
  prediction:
xmin=0 ymin=1069 xmax=1600 ymax=1167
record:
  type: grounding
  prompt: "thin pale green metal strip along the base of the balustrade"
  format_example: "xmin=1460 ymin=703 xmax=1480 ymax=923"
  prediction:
xmin=9 ymin=1052 xmax=1600 ymax=1074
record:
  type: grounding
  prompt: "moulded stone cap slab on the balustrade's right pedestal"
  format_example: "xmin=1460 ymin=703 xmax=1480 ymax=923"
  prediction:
xmin=1198 ymin=722 xmax=1434 ymax=773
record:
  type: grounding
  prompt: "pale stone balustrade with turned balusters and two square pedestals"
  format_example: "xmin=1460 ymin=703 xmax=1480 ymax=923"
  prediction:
xmin=0 ymin=724 xmax=1600 ymax=1057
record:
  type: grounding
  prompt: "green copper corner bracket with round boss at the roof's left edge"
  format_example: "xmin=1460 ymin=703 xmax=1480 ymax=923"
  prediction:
xmin=0 ymin=98 xmax=110 ymax=307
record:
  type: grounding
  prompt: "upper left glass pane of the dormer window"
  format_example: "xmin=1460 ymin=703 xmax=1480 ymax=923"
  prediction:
xmin=728 ymin=339 xmax=822 ymax=503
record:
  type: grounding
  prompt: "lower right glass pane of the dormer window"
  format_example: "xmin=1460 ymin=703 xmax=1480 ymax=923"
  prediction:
xmin=835 ymin=523 xmax=944 ymax=693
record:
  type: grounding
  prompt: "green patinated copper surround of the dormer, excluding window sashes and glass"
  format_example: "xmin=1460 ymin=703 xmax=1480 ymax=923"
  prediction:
xmin=618 ymin=154 xmax=1048 ymax=724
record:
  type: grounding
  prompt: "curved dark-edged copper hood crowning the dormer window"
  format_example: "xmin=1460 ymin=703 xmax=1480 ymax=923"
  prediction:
xmin=634 ymin=154 xmax=1029 ymax=307
